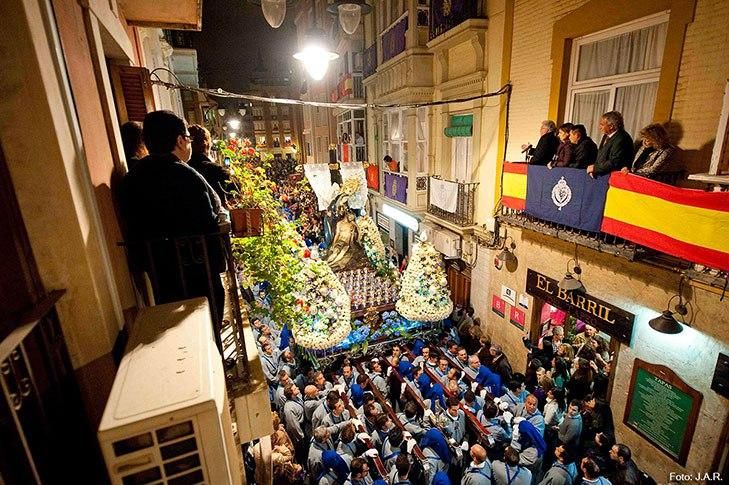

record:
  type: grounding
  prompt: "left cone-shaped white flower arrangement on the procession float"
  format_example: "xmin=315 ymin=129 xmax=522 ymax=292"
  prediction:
xmin=292 ymin=260 xmax=352 ymax=349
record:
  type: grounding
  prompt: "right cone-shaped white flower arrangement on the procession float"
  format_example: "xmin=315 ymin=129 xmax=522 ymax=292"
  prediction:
xmin=395 ymin=237 xmax=453 ymax=322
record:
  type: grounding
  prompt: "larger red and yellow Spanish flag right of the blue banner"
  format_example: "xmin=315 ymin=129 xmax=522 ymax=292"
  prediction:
xmin=601 ymin=172 xmax=729 ymax=270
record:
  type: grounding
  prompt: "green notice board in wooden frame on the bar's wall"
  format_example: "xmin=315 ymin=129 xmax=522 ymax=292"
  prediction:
xmin=623 ymin=359 xmax=704 ymax=465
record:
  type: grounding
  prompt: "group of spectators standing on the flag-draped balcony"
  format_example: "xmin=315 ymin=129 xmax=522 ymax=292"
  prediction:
xmin=522 ymin=111 xmax=678 ymax=178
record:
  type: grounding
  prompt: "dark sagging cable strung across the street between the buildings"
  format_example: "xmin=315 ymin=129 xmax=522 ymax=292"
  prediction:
xmin=150 ymin=67 xmax=511 ymax=109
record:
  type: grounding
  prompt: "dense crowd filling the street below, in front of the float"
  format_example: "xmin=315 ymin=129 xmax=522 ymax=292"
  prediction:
xmin=252 ymin=292 xmax=649 ymax=485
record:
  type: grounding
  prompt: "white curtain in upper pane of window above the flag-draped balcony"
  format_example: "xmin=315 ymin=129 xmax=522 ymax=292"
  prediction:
xmin=577 ymin=22 xmax=668 ymax=81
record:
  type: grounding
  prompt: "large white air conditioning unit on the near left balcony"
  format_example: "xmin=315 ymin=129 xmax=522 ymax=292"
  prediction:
xmin=98 ymin=298 xmax=243 ymax=485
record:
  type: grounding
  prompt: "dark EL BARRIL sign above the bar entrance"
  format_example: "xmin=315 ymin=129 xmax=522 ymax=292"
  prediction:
xmin=526 ymin=269 xmax=635 ymax=345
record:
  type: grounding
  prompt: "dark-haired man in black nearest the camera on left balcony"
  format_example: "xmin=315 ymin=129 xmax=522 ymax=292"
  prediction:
xmin=119 ymin=111 xmax=225 ymax=348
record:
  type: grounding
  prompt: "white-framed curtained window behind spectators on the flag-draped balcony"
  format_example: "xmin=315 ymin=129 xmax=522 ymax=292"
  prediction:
xmin=566 ymin=13 xmax=668 ymax=143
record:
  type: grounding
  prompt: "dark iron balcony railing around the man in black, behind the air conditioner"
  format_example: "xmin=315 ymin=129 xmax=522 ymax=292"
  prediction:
xmin=123 ymin=223 xmax=249 ymax=378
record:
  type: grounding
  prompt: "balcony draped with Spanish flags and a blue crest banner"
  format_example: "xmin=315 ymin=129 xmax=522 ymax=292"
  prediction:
xmin=498 ymin=163 xmax=729 ymax=274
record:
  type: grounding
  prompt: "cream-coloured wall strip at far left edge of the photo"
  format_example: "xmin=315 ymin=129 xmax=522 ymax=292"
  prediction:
xmin=0 ymin=0 xmax=123 ymax=367
